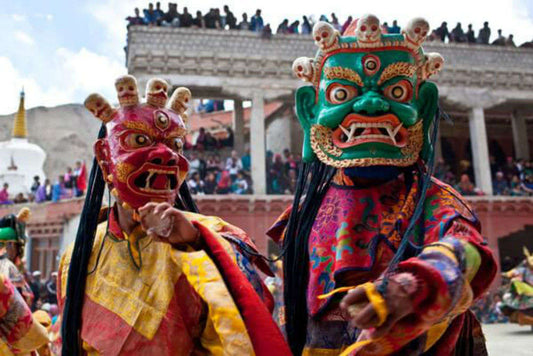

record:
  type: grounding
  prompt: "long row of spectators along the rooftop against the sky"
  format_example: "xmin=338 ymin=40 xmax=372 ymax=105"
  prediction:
xmin=126 ymin=2 xmax=533 ymax=48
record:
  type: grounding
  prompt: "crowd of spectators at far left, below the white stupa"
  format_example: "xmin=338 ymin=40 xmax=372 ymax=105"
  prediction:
xmin=0 ymin=161 xmax=87 ymax=205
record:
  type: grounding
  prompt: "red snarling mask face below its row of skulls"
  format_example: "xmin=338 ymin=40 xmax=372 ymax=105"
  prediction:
xmin=86 ymin=76 xmax=189 ymax=209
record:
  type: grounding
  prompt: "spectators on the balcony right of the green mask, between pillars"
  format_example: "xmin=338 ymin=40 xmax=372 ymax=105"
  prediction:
xmin=435 ymin=156 xmax=533 ymax=196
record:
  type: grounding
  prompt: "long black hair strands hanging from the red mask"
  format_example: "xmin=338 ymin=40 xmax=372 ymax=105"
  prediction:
xmin=61 ymin=125 xmax=198 ymax=356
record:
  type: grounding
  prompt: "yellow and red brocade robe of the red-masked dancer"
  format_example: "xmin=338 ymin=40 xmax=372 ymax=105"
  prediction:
xmin=58 ymin=213 xmax=290 ymax=356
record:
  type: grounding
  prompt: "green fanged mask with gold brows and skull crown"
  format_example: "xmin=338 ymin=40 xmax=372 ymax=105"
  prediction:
xmin=293 ymin=15 xmax=443 ymax=168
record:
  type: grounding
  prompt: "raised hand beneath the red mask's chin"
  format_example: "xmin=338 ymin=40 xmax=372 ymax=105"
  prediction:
xmin=139 ymin=203 xmax=200 ymax=247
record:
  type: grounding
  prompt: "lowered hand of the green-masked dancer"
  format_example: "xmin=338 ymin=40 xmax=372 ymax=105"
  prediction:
xmin=340 ymin=273 xmax=416 ymax=339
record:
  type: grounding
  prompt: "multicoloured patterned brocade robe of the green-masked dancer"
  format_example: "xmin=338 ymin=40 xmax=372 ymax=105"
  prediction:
xmin=268 ymin=171 xmax=496 ymax=356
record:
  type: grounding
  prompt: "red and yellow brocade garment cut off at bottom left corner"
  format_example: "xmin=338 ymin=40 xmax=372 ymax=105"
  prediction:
xmin=0 ymin=274 xmax=49 ymax=356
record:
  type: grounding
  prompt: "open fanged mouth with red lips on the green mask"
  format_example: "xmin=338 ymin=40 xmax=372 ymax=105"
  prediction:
xmin=333 ymin=114 xmax=408 ymax=148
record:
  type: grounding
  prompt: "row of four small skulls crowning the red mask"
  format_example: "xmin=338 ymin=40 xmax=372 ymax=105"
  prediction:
xmin=84 ymin=75 xmax=192 ymax=123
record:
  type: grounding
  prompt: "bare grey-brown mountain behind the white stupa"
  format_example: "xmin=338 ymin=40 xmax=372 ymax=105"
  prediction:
xmin=0 ymin=104 xmax=100 ymax=182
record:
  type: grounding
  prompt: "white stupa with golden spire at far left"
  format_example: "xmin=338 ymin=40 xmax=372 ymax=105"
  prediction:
xmin=0 ymin=90 xmax=46 ymax=195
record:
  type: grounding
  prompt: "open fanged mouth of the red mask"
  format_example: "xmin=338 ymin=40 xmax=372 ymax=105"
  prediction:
xmin=130 ymin=163 xmax=178 ymax=195
